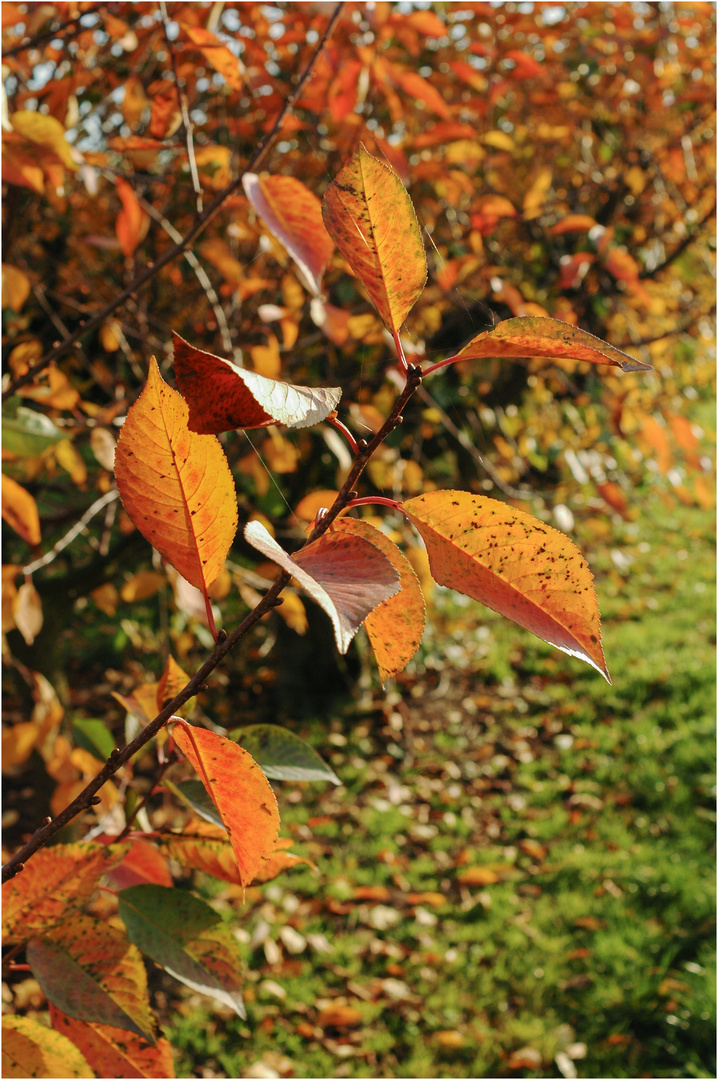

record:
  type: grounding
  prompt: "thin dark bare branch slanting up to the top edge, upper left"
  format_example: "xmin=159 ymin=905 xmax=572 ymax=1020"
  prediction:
xmin=2 ymin=0 xmax=343 ymax=402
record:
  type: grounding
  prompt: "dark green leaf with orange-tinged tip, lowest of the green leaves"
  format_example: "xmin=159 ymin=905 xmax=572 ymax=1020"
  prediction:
xmin=119 ymin=885 xmax=246 ymax=1020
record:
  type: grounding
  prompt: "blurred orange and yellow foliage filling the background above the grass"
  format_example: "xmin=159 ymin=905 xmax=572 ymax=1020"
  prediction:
xmin=2 ymin=0 xmax=715 ymax=1076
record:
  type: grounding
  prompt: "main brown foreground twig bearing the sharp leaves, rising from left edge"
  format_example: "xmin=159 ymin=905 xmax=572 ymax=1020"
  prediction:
xmin=2 ymin=366 xmax=421 ymax=882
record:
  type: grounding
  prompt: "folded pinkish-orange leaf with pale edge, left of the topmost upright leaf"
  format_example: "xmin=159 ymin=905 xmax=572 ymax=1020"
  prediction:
xmin=242 ymin=173 xmax=334 ymax=296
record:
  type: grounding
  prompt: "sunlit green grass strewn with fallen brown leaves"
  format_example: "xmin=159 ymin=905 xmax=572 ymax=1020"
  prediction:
xmin=166 ymin=498 xmax=715 ymax=1077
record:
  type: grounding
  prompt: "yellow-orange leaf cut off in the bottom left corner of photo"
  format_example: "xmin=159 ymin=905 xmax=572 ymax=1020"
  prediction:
xmin=2 ymin=1016 xmax=95 ymax=1080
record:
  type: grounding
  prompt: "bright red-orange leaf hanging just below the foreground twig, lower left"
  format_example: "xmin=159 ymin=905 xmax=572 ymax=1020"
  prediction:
xmin=173 ymin=724 xmax=280 ymax=888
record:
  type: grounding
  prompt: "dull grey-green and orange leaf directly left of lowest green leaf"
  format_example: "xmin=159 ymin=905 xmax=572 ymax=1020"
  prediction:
xmin=27 ymin=915 xmax=155 ymax=1042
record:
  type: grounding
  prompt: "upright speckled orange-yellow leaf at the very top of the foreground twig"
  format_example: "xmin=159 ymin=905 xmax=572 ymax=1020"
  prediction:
xmin=322 ymin=144 xmax=426 ymax=333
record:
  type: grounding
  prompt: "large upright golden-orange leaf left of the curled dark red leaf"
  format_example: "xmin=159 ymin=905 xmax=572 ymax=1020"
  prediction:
xmin=114 ymin=359 xmax=236 ymax=592
